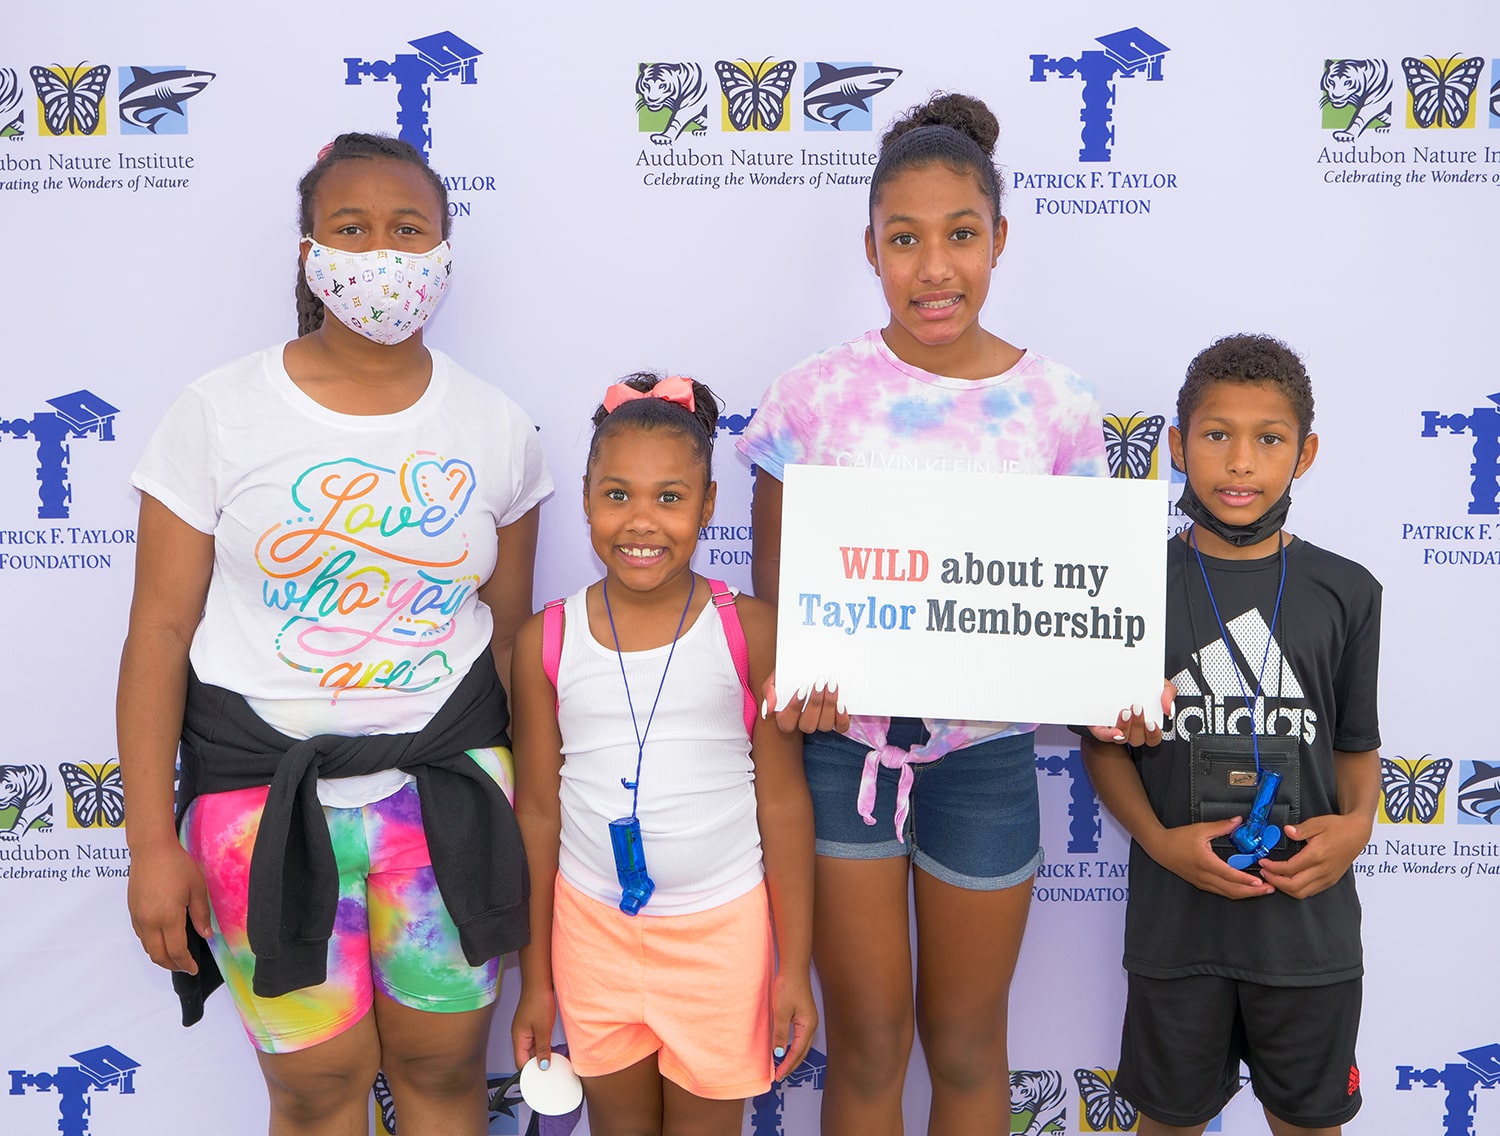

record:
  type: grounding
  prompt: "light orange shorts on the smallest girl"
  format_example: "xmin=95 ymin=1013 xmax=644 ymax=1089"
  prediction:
xmin=552 ymin=873 xmax=774 ymax=1100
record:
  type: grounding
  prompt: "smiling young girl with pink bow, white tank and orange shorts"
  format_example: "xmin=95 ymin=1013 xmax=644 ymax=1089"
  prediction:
xmin=512 ymin=375 xmax=818 ymax=1136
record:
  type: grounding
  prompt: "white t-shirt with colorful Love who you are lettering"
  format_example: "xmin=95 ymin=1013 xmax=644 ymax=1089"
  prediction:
xmin=131 ymin=347 xmax=552 ymax=806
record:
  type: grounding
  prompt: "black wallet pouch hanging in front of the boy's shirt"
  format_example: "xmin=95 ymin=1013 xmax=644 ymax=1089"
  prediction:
xmin=1188 ymin=734 xmax=1304 ymax=860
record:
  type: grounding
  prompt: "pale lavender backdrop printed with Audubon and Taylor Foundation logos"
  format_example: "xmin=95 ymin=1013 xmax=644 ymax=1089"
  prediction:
xmin=0 ymin=0 xmax=1500 ymax=1136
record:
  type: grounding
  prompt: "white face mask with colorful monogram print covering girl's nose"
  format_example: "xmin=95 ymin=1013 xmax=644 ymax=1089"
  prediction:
xmin=302 ymin=237 xmax=453 ymax=347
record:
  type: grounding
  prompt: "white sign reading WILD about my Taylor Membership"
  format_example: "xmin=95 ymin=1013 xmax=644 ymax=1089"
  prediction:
xmin=777 ymin=465 xmax=1167 ymax=725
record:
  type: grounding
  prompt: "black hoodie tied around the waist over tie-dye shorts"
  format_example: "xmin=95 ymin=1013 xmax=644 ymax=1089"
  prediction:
xmin=173 ymin=648 xmax=531 ymax=1025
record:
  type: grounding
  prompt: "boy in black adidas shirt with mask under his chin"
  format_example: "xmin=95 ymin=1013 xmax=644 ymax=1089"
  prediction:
xmin=1083 ymin=336 xmax=1380 ymax=1136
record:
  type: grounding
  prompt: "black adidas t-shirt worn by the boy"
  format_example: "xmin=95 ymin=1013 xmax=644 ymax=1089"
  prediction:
xmin=1125 ymin=539 xmax=1380 ymax=986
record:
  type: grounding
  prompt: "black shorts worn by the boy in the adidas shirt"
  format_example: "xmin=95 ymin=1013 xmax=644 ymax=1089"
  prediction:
xmin=1115 ymin=974 xmax=1362 ymax=1128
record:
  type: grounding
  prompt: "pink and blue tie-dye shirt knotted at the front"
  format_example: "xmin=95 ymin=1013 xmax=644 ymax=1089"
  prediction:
xmin=737 ymin=330 xmax=1109 ymax=831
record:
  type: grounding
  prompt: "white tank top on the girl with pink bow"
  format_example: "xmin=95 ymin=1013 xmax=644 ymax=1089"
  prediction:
xmin=558 ymin=582 xmax=765 ymax=915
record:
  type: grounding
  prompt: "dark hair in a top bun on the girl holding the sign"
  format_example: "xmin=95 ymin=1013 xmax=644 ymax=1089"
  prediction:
xmin=870 ymin=92 xmax=1005 ymax=225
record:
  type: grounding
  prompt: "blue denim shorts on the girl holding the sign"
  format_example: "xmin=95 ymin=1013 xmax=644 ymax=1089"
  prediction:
xmin=803 ymin=732 xmax=1043 ymax=891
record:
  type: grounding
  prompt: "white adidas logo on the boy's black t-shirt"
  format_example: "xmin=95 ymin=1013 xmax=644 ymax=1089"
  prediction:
xmin=1163 ymin=608 xmax=1317 ymax=744
